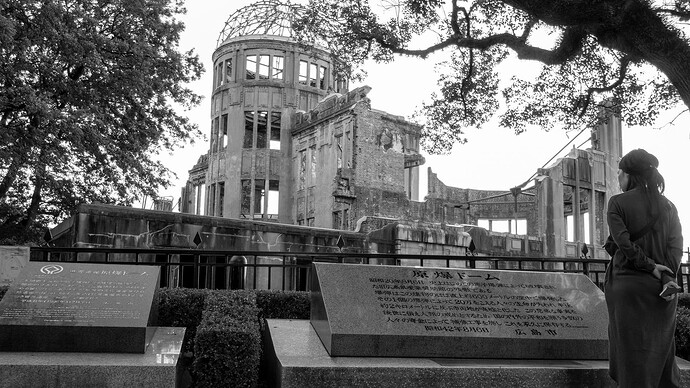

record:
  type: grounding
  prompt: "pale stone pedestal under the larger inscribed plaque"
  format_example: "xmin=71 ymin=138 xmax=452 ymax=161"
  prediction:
xmin=265 ymin=320 xmax=690 ymax=388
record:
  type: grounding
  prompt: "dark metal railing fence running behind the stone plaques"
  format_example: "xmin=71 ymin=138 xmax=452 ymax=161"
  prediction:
xmin=30 ymin=247 xmax=690 ymax=291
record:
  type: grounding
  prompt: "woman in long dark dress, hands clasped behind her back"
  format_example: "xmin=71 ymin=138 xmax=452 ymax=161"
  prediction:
xmin=604 ymin=149 xmax=683 ymax=388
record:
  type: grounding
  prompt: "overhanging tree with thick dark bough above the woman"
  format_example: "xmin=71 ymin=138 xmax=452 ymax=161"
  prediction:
xmin=294 ymin=0 xmax=690 ymax=152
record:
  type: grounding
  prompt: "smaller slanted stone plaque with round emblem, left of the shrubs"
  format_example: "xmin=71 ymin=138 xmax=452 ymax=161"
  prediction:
xmin=0 ymin=262 xmax=160 ymax=353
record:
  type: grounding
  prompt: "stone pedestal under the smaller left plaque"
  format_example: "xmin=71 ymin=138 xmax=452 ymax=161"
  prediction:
xmin=0 ymin=327 xmax=185 ymax=388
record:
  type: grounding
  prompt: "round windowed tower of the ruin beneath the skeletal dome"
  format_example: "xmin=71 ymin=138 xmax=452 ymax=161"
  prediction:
xmin=182 ymin=36 xmax=347 ymax=223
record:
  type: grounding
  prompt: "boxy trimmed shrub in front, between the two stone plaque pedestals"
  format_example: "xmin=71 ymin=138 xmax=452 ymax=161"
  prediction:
xmin=193 ymin=291 xmax=261 ymax=387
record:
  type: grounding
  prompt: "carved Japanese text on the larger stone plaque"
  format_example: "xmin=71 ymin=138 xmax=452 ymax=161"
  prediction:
xmin=369 ymin=269 xmax=588 ymax=337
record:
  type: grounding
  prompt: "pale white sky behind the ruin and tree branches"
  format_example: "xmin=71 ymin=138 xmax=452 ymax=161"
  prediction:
xmin=156 ymin=0 xmax=690 ymax=247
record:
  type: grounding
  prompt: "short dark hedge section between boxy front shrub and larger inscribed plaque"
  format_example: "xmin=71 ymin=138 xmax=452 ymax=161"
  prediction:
xmin=256 ymin=290 xmax=311 ymax=319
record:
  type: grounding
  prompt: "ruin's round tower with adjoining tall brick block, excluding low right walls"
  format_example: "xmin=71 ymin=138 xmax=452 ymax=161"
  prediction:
xmin=181 ymin=25 xmax=423 ymax=230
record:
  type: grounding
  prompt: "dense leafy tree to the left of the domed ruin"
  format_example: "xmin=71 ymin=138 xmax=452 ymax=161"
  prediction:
xmin=0 ymin=0 xmax=203 ymax=243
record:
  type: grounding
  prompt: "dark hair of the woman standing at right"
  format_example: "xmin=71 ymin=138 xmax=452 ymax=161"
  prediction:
xmin=618 ymin=148 xmax=666 ymax=215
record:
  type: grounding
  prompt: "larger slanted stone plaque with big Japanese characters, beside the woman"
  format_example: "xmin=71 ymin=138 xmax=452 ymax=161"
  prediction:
xmin=311 ymin=263 xmax=608 ymax=360
